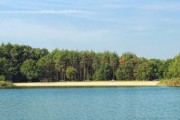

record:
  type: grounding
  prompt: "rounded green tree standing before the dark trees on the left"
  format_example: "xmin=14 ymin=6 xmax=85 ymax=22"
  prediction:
xmin=20 ymin=59 xmax=38 ymax=81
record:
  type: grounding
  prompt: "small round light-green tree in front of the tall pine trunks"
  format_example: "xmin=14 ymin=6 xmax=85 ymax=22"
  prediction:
xmin=66 ymin=67 xmax=77 ymax=80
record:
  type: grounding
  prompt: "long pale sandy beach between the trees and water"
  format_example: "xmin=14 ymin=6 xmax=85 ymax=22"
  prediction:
xmin=14 ymin=81 xmax=158 ymax=87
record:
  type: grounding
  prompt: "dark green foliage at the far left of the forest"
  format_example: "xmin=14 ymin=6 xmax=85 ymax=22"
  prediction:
xmin=0 ymin=43 xmax=48 ymax=82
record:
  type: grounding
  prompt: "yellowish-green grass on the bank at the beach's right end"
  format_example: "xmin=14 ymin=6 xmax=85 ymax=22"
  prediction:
xmin=158 ymin=78 xmax=180 ymax=87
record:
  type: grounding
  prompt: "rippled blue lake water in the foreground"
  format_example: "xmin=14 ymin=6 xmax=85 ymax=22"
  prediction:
xmin=0 ymin=87 xmax=180 ymax=120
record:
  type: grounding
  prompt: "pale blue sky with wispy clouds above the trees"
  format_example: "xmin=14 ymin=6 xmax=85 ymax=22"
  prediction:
xmin=0 ymin=0 xmax=180 ymax=59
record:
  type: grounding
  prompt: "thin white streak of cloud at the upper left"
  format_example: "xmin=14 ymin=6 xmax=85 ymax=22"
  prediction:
xmin=0 ymin=9 xmax=91 ymax=14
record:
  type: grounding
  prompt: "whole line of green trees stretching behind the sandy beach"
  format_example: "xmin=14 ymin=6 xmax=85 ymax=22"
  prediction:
xmin=0 ymin=43 xmax=180 ymax=82
